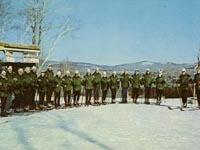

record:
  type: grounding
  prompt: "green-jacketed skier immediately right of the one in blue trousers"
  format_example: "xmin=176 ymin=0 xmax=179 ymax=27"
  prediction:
xmin=130 ymin=69 xmax=142 ymax=103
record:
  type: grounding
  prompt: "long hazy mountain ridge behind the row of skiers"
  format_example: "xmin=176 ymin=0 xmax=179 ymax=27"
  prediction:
xmin=46 ymin=61 xmax=195 ymax=76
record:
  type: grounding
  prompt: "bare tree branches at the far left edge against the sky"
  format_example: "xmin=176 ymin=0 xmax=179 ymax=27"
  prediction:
xmin=0 ymin=0 xmax=12 ymax=40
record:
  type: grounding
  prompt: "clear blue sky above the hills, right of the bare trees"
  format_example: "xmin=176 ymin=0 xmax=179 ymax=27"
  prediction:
xmin=4 ymin=0 xmax=200 ymax=65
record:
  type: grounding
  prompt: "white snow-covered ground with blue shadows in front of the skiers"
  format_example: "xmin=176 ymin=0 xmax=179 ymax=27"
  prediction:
xmin=0 ymin=99 xmax=200 ymax=150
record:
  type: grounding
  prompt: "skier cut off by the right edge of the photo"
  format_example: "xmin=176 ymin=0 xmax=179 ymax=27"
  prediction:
xmin=193 ymin=67 xmax=200 ymax=108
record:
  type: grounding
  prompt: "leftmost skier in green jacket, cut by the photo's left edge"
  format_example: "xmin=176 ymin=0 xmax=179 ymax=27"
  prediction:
xmin=0 ymin=70 xmax=8 ymax=117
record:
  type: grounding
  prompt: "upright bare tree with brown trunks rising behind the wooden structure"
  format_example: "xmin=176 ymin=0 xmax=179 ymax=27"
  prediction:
xmin=16 ymin=0 xmax=48 ymax=46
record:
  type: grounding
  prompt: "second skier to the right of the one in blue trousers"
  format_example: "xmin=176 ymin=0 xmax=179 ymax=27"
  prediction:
xmin=142 ymin=69 xmax=154 ymax=104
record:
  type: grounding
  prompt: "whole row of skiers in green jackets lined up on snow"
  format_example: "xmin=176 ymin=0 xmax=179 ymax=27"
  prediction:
xmin=0 ymin=65 xmax=200 ymax=116
